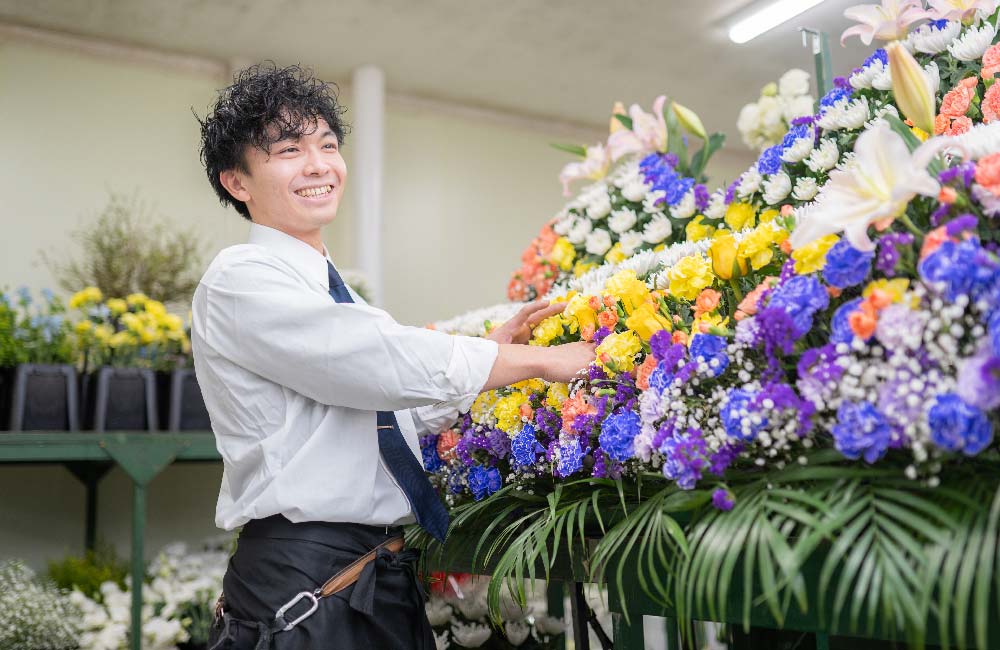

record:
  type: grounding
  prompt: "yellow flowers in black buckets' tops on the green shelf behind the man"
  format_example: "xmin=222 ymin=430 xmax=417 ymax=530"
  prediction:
xmin=69 ymin=287 xmax=191 ymax=371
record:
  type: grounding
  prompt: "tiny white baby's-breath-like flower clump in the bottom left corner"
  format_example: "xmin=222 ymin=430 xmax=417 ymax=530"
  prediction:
xmin=0 ymin=561 xmax=79 ymax=650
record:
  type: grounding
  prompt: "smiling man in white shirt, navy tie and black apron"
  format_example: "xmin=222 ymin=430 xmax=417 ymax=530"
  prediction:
xmin=191 ymin=65 xmax=594 ymax=650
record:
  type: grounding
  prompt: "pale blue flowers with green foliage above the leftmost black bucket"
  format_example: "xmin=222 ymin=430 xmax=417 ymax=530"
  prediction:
xmin=0 ymin=287 xmax=75 ymax=368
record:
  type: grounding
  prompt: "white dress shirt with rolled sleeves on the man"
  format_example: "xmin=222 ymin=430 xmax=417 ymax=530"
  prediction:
xmin=191 ymin=224 xmax=499 ymax=530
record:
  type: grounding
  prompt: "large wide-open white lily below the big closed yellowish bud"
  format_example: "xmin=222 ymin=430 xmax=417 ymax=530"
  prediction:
xmin=791 ymin=120 xmax=948 ymax=251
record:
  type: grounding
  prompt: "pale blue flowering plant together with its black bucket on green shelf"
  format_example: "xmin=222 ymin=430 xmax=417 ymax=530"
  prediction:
xmin=0 ymin=288 xmax=80 ymax=431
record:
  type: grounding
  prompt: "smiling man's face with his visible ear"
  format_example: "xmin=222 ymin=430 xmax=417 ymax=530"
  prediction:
xmin=223 ymin=118 xmax=347 ymax=235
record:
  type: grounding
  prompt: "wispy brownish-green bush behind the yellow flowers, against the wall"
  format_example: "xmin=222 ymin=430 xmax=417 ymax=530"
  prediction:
xmin=41 ymin=192 xmax=201 ymax=303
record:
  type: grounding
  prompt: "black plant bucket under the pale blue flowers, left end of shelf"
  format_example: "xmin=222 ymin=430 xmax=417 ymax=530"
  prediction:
xmin=0 ymin=363 xmax=80 ymax=431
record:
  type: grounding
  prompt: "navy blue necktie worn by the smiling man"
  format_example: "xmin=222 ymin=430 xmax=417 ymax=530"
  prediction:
xmin=326 ymin=262 xmax=448 ymax=543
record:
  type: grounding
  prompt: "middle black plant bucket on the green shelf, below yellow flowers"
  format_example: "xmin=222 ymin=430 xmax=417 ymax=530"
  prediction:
xmin=81 ymin=366 xmax=158 ymax=431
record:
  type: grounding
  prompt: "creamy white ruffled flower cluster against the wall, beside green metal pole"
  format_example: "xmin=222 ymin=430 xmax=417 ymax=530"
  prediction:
xmin=736 ymin=68 xmax=815 ymax=151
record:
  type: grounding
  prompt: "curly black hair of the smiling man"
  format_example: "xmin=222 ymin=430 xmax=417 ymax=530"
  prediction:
xmin=195 ymin=61 xmax=350 ymax=220
